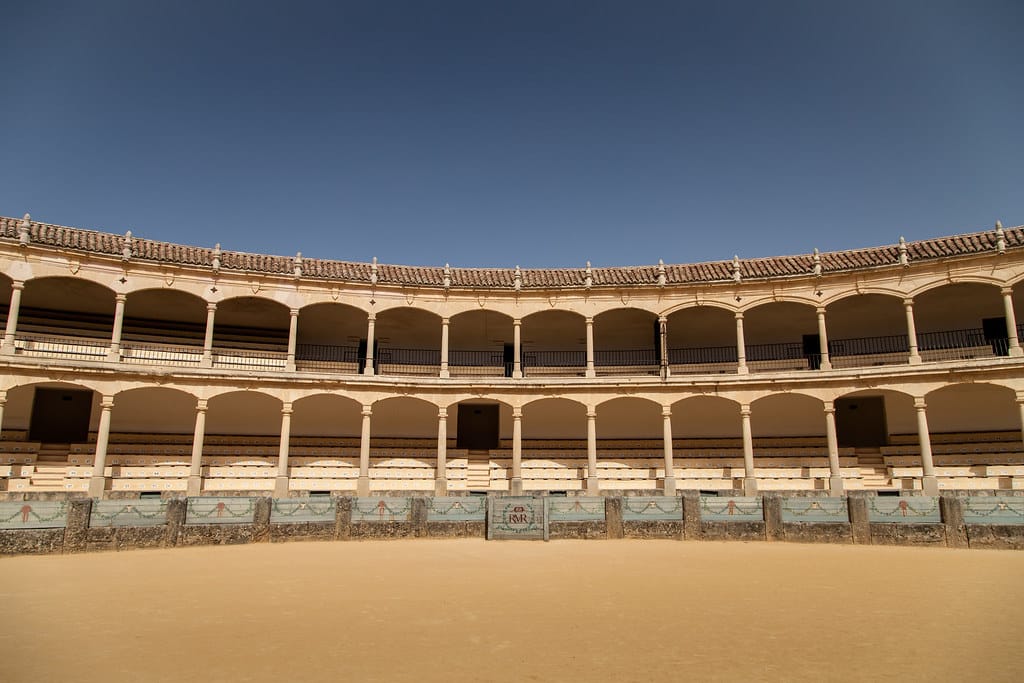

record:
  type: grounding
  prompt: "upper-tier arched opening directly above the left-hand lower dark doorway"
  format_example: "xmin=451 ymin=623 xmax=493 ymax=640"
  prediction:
xmin=14 ymin=278 xmax=114 ymax=360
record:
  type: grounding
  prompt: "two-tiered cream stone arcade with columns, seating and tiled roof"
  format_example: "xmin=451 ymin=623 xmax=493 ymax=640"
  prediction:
xmin=0 ymin=217 xmax=1024 ymax=497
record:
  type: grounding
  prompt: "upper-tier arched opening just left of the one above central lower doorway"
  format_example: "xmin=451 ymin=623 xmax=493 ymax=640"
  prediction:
xmin=374 ymin=306 xmax=441 ymax=376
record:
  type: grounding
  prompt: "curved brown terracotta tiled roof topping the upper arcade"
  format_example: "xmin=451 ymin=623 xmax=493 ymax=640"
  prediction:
xmin=0 ymin=217 xmax=1024 ymax=290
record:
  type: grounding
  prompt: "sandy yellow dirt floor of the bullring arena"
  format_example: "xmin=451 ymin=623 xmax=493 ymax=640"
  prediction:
xmin=0 ymin=540 xmax=1024 ymax=682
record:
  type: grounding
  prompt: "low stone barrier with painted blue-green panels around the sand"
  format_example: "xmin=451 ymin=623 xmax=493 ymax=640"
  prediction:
xmin=0 ymin=493 xmax=1024 ymax=554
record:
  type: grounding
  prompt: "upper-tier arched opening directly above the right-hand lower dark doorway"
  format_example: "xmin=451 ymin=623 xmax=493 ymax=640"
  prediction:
xmin=825 ymin=294 xmax=909 ymax=368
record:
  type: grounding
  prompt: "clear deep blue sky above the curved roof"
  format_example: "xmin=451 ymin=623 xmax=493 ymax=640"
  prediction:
xmin=0 ymin=0 xmax=1024 ymax=267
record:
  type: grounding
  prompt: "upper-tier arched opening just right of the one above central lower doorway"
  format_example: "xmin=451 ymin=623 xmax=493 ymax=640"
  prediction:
xmin=522 ymin=310 xmax=587 ymax=377
